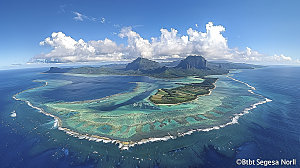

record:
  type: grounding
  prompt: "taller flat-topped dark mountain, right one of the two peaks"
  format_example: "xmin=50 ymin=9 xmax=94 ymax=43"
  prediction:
xmin=176 ymin=56 xmax=207 ymax=69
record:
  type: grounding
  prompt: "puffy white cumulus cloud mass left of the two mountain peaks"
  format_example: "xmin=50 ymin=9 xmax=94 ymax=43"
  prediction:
xmin=34 ymin=32 xmax=123 ymax=62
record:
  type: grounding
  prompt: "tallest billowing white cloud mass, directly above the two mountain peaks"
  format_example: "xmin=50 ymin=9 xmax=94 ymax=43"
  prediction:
xmin=119 ymin=22 xmax=232 ymax=59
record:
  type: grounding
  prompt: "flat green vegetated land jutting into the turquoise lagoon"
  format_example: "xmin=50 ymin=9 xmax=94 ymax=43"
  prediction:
xmin=150 ymin=78 xmax=218 ymax=105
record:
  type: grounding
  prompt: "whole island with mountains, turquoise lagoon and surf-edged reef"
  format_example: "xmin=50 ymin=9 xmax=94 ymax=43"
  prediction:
xmin=13 ymin=56 xmax=269 ymax=149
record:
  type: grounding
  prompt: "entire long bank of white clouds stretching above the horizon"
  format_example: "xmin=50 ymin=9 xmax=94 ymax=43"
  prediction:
xmin=34 ymin=22 xmax=293 ymax=63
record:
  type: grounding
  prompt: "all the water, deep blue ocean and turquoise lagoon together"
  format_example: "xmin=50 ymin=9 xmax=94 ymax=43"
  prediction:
xmin=0 ymin=67 xmax=300 ymax=167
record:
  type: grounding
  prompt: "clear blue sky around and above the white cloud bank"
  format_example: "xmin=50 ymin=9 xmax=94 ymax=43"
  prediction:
xmin=0 ymin=0 xmax=300 ymax=66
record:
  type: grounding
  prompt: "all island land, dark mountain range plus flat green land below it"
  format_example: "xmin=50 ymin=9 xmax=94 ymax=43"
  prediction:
xmin=46 ymin=56 xmax=261 ymax=105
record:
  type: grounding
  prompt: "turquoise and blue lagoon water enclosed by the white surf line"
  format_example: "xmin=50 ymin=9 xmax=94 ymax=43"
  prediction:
xmin=15 ymin=69 xmax=264 ymax=146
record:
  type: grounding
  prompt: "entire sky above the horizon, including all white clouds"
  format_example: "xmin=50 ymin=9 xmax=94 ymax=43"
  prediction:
xmin=0 ymin=0 xmax=300 ymax=67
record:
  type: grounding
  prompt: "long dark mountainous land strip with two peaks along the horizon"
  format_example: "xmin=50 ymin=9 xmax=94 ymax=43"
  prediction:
xmin=46 ymin=56 xmax=262 ymax=78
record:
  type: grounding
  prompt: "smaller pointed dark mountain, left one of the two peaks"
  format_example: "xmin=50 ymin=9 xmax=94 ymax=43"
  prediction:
xmin=125 ymin=57 xmax=161 ymax=71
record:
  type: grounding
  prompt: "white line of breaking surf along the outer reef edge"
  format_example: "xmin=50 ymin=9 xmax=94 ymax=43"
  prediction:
xmin=12 ymin=75 xmax=272 ymax=150
